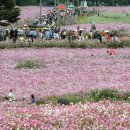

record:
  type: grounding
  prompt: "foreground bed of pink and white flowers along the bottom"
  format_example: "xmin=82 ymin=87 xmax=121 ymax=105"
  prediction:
xmin=0 ymin=101 xmax=130 ymax=130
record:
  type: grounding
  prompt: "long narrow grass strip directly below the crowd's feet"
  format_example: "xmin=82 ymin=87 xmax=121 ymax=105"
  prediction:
xmin=0 ymin=39 xmax=130 ymax=49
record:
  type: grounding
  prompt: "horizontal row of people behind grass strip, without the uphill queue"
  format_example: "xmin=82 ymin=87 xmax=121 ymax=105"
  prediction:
xmin=0 ymin=25 xmax=128 ymax=43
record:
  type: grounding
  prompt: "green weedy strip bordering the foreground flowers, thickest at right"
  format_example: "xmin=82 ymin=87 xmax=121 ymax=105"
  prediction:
xmin=36 ymin=89 xmax=130 ymax=105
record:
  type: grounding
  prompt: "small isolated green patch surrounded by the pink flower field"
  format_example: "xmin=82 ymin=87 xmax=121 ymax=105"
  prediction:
xmin=15 ymin=60 xmax=45 ymax=69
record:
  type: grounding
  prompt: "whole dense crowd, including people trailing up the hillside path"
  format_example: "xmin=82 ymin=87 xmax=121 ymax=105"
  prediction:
xmin=0 ymin=7 xmax=128 ymax=43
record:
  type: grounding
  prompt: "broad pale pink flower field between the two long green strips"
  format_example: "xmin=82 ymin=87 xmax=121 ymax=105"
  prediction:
xmin=0 ymin=48 xmax=130 ymax=98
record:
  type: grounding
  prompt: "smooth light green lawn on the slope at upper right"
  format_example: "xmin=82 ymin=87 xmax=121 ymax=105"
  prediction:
xmin=78 ymin=11 xmax=130 ymax=24
